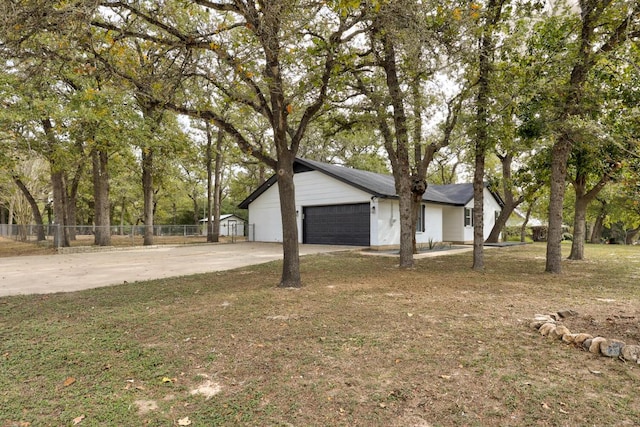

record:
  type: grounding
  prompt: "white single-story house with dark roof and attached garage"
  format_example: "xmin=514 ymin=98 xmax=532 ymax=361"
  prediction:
xmin=239 ymin=159 xmax=503 ymax=250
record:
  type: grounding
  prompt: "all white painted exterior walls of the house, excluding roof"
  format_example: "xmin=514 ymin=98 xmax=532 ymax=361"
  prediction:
xmin=249 ymin=171 xmax=500 ymax=247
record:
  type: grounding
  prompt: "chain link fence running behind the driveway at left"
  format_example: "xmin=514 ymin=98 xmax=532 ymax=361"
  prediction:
xmin=0 ymin=223 xmax=255 ymax=247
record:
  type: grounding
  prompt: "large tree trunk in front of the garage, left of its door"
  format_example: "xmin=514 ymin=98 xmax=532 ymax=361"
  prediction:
xmin=277 ymin=154 xmax=302 ymax=288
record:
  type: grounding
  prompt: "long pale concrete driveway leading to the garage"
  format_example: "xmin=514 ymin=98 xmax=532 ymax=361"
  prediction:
xmin=0 ymin=242 xmax=361 ymax=296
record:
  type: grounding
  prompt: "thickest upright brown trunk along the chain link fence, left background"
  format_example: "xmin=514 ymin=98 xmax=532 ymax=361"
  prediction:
xmin=91 ymin=150 xmax=111 ymax=246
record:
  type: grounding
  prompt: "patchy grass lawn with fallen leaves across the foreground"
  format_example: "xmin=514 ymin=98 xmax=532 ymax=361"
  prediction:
xmin=0 ymin=244 xmax=640 ymax=426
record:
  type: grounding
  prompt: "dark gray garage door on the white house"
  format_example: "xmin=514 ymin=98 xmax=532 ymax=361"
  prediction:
xmin=302 ymin=203 xmax=371 ymax=246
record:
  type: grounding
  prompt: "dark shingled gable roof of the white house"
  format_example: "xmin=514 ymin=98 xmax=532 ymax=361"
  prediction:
xmin=238 ymin=158 xmax=503 ymax=209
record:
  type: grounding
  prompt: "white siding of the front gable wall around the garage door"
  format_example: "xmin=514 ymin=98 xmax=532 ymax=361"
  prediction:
xmin=249 ymin=171 xmax=374 ymax=244
